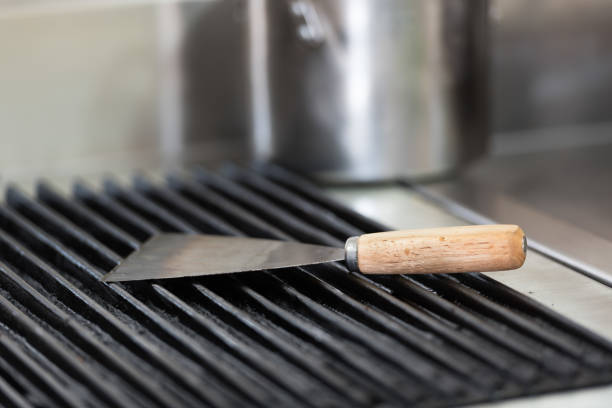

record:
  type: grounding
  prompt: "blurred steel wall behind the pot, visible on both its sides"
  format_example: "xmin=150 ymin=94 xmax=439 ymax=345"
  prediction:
xmin=0 ymin=0 xmax=612 ymax=178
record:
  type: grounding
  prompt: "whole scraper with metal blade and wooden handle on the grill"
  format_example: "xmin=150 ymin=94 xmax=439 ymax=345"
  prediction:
xmin=102 ymin=225 xmax=527 ymax=282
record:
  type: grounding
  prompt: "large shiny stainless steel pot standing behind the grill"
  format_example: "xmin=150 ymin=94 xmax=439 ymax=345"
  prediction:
xmin=251 ymin=0 xmax=487 ymax=181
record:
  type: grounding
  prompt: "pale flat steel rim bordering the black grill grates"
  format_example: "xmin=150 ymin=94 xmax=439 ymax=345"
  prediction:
xmin=327 ymin=185 xmax=612 ymax=408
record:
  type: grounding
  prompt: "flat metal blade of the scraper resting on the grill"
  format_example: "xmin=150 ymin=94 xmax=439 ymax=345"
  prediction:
xmin=102 ymin=234 xmax=344 ymax=282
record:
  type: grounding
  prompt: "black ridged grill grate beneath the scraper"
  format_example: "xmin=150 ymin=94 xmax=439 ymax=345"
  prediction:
xmin=0 ymin=163 xmax=612 ymax=407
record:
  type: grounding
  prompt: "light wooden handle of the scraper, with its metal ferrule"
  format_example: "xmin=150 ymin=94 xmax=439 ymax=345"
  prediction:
xmin=346 ymin=225 xmax=527 ymax=274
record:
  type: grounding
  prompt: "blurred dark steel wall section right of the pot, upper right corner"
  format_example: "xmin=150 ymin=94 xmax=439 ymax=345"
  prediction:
xmin=491 ymin=0 xmax=612 ymax=132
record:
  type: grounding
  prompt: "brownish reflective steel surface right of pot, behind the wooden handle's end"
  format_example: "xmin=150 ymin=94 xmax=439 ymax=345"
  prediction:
xmin=424 ymin=140 xmax=612 ymax=286
